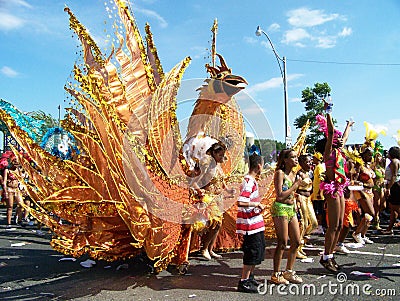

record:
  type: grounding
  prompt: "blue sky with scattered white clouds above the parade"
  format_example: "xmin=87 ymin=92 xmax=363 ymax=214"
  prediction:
xmin=0 ymin=0 xmax=400 ymax=147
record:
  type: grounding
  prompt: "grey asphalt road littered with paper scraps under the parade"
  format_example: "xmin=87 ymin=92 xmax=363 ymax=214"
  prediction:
xmin=0 ymin=208 xmax=400 ymax=301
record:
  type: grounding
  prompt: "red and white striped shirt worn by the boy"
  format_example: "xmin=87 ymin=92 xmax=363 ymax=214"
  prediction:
xmin=236 ymin=175 xmax=265 ymax=235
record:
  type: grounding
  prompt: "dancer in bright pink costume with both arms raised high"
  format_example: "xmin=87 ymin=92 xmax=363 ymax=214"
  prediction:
xmin=315 ymin=101 xmax=353 ymax=272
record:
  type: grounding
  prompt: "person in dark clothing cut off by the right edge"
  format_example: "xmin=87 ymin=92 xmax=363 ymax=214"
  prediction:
xmin=382 ymin=146 xmax=400 ymax=235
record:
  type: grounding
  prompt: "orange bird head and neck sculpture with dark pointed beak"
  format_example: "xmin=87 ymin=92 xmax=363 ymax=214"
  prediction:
xmin=184 ymin=54 xmax=247 ymax=177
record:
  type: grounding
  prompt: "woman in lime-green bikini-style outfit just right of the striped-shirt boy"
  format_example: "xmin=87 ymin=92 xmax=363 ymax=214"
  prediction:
xmin=271 ymin=149 xmax=303 ymax=284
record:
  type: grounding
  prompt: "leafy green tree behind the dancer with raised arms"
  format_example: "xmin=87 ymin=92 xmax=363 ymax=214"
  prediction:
xmin=294 ymin=83 xmax=331 ymax=149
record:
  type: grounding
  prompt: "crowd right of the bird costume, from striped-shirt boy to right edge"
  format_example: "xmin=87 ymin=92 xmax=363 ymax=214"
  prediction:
xmin=237 ymin=103 xmax=400 ymax=293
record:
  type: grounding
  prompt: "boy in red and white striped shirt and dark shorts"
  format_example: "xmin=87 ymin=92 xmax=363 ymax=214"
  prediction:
xmin=236 ymin=153 xmax=265 ymax=293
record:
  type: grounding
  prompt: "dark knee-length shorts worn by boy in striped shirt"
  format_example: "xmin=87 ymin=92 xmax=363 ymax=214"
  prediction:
xmin=242 ymin=231 xmax=266 ymax=265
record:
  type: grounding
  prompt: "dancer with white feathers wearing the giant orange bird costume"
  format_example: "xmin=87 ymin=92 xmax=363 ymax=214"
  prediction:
xmin=173 ymin=133 xmax=234 ymax=274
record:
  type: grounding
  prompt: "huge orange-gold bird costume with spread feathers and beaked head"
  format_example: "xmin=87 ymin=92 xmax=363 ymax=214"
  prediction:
xmin=0 ymin=0 xmax=250 ymax=270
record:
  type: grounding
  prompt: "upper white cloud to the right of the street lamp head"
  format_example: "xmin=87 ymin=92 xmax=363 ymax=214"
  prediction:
xmin=287 ymin=7 xmax=339 ymax=27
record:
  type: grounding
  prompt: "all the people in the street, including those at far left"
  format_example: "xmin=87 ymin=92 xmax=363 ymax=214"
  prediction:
xmin=0 ymin=103 xmax=400 ymax=293
